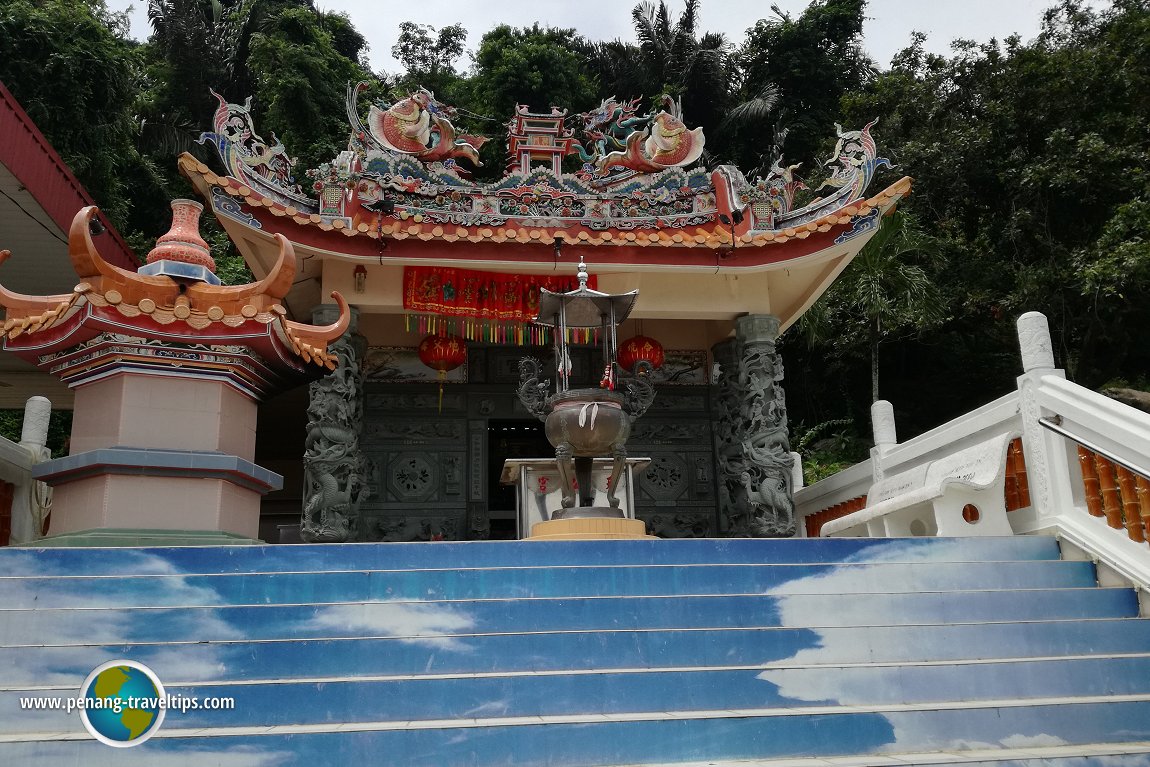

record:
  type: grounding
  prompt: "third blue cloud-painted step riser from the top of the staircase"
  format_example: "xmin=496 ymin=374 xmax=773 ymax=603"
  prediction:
xmin=0 ymin=588 xmax=1139 ymax=651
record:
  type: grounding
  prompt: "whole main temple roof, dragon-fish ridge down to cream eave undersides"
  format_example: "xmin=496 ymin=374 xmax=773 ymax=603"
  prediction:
xmin=178 ymin=84 xmax=911 ymax=327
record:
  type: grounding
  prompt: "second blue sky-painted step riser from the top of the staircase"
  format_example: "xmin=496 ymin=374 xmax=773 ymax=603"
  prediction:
xmin=0 ymin=560 xmax=1096 ymax=609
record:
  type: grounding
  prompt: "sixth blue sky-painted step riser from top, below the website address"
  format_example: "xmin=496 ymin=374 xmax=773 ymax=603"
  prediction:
xmin=0 ymin=696 xmax=1150 ymax=767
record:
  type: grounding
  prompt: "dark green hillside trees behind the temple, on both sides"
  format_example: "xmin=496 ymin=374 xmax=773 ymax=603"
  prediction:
xmin=0 ymin=0 xmax=1150 ymax=469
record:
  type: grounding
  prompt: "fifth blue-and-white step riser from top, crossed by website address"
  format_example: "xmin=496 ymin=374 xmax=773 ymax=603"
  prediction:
xmin=11 ymin=655 xmax=1150 ymax=734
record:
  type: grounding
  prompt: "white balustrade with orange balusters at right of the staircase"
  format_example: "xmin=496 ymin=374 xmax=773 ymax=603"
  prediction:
xmin=795 ymin=312 xmax=1150 ymax=588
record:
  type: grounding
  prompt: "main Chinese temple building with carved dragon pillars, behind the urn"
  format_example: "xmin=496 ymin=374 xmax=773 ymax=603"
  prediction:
xmin=179 ymin=87 xmax=910 ymax=540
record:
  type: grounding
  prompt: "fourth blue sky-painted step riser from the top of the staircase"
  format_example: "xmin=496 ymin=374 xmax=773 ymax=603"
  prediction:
xmin=0 ymin=619 xmax=1150 ymax=688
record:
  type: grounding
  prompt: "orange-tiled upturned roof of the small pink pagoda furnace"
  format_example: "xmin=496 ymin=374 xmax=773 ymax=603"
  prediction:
xmin=0 ymin=201 xmax=351 ymax=397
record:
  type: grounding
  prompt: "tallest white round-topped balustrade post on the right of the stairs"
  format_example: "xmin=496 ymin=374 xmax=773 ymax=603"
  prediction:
xmin=1018 ymin=312 xmax=1079 ymax=522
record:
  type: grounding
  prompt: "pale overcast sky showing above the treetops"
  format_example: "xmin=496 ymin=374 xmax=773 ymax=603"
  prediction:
xmin=108 ymin=0 xmax=1085 ymax=72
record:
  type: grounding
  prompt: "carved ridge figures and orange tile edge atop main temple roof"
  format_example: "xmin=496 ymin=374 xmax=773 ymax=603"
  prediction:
xmin=179 ymin=84 xmax=911 ymax=270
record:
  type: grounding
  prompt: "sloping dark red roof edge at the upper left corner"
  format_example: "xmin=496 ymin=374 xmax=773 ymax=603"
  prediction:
xmin=0 ymin=83 xmax=139 ymax=271
